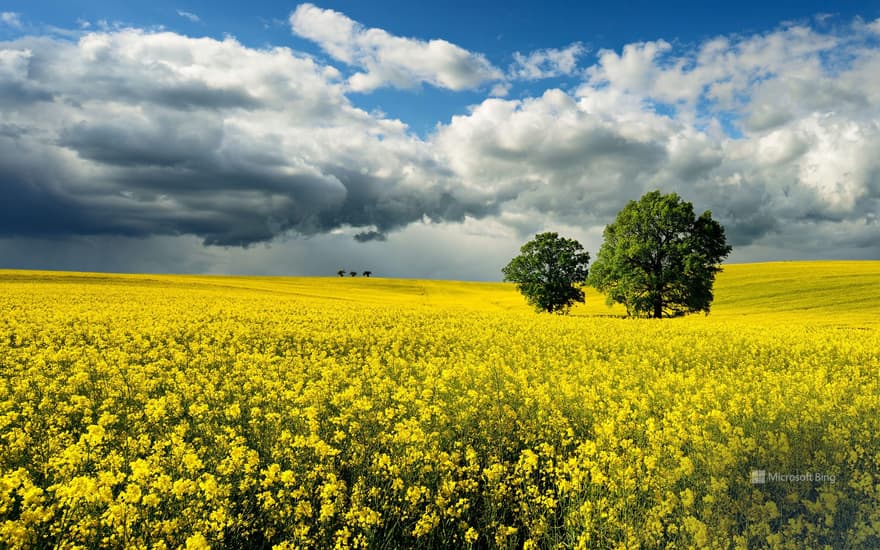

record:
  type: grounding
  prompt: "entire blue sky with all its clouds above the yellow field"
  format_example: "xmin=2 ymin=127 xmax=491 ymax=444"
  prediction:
xmin=0 ymin=0 xmax=880 ymax=280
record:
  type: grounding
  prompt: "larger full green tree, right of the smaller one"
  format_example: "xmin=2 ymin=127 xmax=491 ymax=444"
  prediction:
xmin=589 ymin=191 xmax=731 ymax=318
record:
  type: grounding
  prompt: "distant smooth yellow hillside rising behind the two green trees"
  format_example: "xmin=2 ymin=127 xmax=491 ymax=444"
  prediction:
xmin=0 ymin=261 xmax=880 ymax=325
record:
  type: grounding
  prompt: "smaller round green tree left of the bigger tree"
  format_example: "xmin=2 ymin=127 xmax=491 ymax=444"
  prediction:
xmin=501 ymin=233 xmax=590 ymax=313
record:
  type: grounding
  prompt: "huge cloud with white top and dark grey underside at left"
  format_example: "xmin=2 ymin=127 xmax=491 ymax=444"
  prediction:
xmin=0 ymin=30 xmax=506 ymax=246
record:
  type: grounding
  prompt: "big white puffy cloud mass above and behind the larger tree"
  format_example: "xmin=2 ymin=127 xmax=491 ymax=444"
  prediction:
xmin=434 ymin=18 xmax=880 ymax=259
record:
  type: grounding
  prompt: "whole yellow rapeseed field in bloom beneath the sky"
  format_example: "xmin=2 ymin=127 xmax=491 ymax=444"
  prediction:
xmin=0 ymin=262 xmax=880 ymax=549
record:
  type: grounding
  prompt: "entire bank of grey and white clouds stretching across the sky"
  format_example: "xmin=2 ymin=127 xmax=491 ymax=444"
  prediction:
xmin=0 ymin=11 xmax=880 ymax=280
